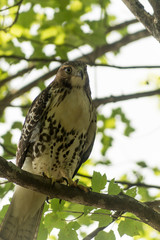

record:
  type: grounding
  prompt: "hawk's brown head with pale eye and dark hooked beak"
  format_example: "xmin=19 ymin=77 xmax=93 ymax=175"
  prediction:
xmin=55 ymin=61 xmax=89 ymax=88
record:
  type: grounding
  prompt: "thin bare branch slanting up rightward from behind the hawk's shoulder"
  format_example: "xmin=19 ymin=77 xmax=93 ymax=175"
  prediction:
xmin=93 ymin=89 xmax=160 ymax=108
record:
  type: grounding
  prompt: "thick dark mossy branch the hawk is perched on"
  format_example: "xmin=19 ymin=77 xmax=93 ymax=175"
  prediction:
xmin=0 ymin=157 xmax=160 ymax=231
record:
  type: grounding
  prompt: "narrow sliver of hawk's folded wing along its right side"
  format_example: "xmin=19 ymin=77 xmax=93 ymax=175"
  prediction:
xmin=73 ymin=106 xmax=97 ymax=177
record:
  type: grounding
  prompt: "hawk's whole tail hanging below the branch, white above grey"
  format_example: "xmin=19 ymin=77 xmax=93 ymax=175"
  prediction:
xmin=0 ymin=186 xmax=46 ymax=240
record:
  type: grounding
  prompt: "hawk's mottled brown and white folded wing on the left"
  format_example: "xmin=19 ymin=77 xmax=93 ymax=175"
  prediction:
xmin=16 ymin=85 xmax=51 ymax=168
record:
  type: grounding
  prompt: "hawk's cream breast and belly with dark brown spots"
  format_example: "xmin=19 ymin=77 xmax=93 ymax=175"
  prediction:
xmin=32 ymin=88 xmax=92 ymax=179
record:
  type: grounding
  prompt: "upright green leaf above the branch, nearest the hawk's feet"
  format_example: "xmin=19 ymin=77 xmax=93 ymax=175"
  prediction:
xmin=91 ymin=171 xmax=107 ymax=192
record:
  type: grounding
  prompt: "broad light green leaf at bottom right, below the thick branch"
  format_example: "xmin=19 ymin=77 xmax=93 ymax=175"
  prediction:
xmin=118 ymin=218 xmax=142 ymax=237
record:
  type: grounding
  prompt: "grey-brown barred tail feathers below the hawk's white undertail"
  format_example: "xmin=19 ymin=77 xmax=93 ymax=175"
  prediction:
xmin=0 ymin=201 xmax=44 ymax=240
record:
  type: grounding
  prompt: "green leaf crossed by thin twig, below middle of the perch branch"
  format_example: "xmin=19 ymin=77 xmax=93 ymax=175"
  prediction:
xmin=91 ymin=209 xmax=112 ymax=227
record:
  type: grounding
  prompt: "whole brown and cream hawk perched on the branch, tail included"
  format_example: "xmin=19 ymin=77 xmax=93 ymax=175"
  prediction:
xmin=0 ymin=61 xmax=96 ymax=240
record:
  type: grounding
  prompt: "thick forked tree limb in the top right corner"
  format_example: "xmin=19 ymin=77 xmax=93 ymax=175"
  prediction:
xmin=122 ymin=0 xmax=160 ymax=41
